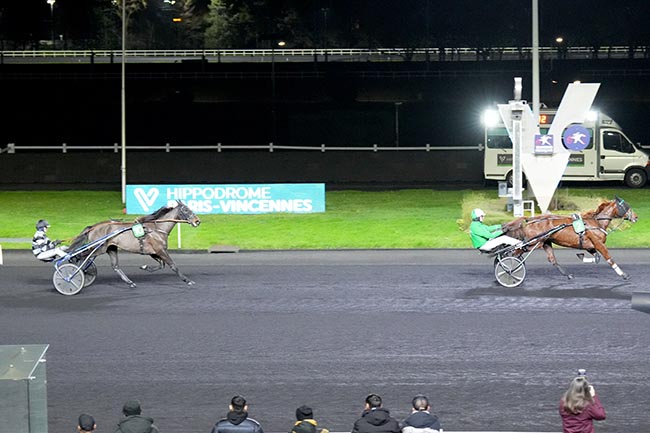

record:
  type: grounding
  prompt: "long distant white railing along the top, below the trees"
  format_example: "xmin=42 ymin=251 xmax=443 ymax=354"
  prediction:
xmin=0 ymin=46 xmax=650 ymax=62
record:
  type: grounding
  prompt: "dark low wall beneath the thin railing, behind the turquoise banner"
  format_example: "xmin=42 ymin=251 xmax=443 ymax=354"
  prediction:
xmin=0 ymin=150 xmax=483 ymax=187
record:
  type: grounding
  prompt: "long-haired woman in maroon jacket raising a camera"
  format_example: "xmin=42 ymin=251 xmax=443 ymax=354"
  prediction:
xmin=560 ymin=376 xmax=606 ymax=433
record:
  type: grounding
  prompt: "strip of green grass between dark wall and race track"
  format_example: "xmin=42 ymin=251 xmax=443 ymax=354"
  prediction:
xmin=0 ymin=188 xmax=650 ymax=250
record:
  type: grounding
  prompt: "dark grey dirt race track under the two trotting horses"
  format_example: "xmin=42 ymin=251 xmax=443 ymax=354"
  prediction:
xmin=0 ymin=246 xmax=650 ymax=433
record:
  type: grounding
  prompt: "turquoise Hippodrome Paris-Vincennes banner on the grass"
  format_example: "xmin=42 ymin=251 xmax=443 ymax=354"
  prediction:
xmin=126 ymin=183 xmax=325 ymax=214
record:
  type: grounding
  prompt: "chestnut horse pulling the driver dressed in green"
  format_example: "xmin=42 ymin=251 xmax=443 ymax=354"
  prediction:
xmin=503 ymin=197 xmax=638 ymax=280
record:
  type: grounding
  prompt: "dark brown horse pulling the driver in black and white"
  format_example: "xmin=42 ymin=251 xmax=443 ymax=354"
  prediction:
xmin=69 ymin=200 xmax=201 ymax=287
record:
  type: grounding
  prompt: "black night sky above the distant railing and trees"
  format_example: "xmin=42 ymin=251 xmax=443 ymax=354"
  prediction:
xmin=0 ymin=0 xmax=650 ymax=49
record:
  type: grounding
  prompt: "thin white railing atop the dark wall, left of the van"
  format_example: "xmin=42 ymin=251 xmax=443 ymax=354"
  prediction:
xmin=0 ymin=143 xmax=483 ymax=154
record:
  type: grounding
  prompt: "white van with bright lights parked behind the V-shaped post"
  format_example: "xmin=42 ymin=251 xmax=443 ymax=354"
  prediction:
xmin=483 ymin=109 xmax=650 ymax=188
